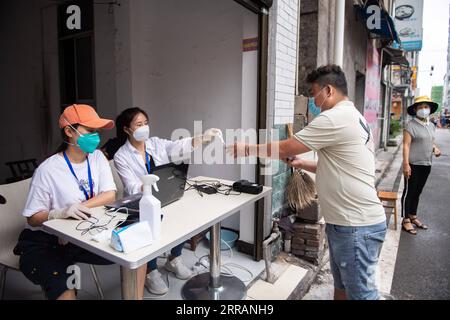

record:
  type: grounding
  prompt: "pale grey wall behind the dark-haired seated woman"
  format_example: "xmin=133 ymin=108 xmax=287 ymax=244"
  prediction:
xmin=110 ymin=0 xmax=258 ymax=231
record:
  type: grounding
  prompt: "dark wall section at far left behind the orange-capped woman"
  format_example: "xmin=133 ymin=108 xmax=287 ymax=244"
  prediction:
xmin=0 ymin=0 xmax=59 ymax=183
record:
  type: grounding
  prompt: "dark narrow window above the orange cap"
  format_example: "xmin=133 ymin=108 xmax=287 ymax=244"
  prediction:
xmin=58 ymin=0 xmax=95 ymax=108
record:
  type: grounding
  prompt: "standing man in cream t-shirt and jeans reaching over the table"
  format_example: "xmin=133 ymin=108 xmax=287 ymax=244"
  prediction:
xmin=228 ymin=65 xmax=386 ymax=300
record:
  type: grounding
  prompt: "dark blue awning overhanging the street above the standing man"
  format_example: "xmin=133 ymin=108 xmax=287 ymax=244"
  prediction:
xmin=353 ymin=0 xmax=400 ymax=43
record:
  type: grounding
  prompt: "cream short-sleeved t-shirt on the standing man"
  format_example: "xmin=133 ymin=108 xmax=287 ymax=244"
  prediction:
xmin=295 ymin=101 xmax=386 ymax=227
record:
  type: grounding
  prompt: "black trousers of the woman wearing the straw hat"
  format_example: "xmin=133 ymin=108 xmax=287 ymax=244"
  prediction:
xmin=402 ymin=164 xmax=431 ymax=218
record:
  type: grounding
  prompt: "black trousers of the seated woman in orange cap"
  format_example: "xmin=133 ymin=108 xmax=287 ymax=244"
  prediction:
xmin=14 ymin=229 xmax=112 ymax=300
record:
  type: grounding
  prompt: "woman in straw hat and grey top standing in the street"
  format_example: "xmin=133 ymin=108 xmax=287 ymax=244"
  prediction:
xmin=402 ymin=96 xmax=441 ymax=235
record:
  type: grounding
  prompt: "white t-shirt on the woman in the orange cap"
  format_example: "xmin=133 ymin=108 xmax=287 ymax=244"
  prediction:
xmin=22 ymin=150 xmax=117 ymax=228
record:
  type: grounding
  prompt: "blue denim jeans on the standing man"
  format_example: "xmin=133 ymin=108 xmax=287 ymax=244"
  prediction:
xmin=326 ymin=222 xmax=387 ymax=300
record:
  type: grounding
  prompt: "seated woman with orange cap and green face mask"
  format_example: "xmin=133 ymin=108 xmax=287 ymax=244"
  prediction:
xmin=14 ymin=105 xmax=116 ymax=300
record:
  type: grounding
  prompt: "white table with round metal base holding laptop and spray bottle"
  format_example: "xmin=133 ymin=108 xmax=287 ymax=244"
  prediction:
xmin=44 ymin=177 xmax=271 ymax=300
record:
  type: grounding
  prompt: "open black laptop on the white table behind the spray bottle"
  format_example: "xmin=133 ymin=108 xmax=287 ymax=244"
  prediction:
xmin=105 ymin=163 xmax=189 ymax=216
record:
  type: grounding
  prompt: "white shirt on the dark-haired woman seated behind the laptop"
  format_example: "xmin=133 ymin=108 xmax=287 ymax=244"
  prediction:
xmin=114 ymin=137 xmax=193 ymax=196
